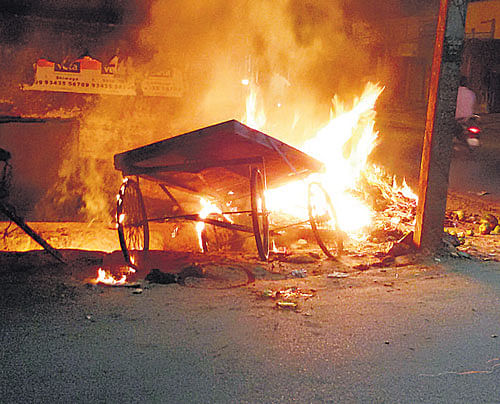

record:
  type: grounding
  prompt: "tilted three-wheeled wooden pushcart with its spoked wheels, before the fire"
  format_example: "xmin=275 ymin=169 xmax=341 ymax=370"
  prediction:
xmin=114 ymin=120 xmax=341 ymax=263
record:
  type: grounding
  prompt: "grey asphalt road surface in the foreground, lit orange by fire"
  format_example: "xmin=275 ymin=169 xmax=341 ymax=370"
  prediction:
xmin=0 ymin=254 xmax=500 ymax=403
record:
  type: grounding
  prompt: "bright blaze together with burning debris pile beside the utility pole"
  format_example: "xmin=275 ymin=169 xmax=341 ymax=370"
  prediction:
xmin=267 ymin=83 xmax=417 ymax=258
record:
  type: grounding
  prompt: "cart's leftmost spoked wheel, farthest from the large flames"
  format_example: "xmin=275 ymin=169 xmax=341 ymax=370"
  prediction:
xmin=116 ymin=178 xmax=149 ymax=266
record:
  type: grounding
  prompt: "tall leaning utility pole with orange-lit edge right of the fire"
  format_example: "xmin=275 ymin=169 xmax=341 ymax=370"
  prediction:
xmin=413 ymin=0 xmax=468 ymax=254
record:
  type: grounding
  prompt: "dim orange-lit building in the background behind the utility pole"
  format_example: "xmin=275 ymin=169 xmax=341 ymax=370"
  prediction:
xmin=362 ymin=0 xmax=500 ymax=113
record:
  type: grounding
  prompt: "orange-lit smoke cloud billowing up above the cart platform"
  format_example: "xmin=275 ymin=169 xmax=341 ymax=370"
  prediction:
xmin=130 ymin=0 xmax=382 ymax=143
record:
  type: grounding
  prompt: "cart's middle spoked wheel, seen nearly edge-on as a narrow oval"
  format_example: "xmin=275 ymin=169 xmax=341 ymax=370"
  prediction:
xmin=250 ymin=168 xmax=269 ymax=261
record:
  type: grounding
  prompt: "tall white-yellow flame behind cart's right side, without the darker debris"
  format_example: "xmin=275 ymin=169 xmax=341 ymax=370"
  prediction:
xmin=266 ymin=83 xmax=383 ymax=236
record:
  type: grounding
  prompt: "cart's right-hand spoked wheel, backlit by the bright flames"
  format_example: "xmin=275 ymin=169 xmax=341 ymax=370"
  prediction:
xmin=307 ymin=182 xmax=344 ymax=258
